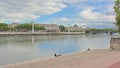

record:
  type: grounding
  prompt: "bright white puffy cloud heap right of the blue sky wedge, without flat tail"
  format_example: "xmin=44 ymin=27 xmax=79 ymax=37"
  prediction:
xmin=78 ymin=8 xmax=115 ymax=22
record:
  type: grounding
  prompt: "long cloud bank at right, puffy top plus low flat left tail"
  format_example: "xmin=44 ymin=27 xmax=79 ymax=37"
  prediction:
xmin=47 ymin=7 xmax=115 ymax=27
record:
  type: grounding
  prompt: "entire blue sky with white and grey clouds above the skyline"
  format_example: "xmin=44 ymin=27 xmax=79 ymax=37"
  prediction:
xmin=0 ymin=0 xmax=115 ymax=28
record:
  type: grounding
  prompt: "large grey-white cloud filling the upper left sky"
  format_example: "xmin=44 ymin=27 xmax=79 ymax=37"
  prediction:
xmin=0 ymin=0 xmax=67 ymax=22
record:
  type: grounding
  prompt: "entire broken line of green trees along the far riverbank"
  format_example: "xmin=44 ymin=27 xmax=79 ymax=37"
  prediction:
xmin=0 ymin=23 xmax=118 ymax=33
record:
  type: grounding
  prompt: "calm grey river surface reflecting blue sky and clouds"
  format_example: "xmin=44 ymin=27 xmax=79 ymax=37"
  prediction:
xmin=0 ymin=34 xmax=110 ymax=66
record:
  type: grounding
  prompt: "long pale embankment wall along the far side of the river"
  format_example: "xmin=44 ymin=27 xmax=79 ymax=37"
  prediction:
xmin=0 ymin=32 xmax=85 ymax=35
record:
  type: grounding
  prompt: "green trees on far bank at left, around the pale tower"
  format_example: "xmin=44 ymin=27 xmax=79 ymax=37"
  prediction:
xmin=0 ymin=23 xmax=45 ymax=31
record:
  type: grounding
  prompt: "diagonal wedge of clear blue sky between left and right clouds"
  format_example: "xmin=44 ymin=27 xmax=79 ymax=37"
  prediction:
xmin=36 ymin=7 xmax=77 ymax=23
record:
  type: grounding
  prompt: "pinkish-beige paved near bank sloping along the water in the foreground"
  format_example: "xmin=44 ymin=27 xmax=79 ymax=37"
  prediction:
xmin=2 ymin=49 xmax=120 ymax=68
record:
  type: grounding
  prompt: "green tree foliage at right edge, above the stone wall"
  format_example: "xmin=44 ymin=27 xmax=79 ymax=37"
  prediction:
xmin=114 ymin=0 xmax=120 ymax=32
